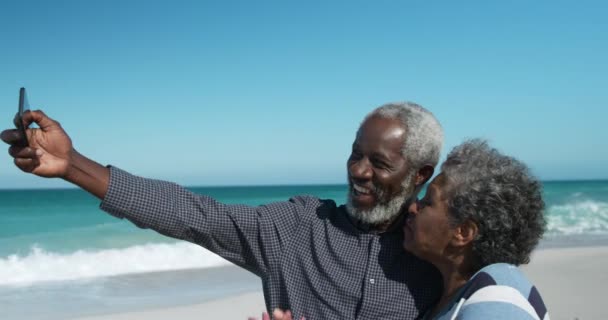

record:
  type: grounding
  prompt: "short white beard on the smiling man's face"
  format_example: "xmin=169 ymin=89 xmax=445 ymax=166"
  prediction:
xmin=346 ymin=171 xmax=415 ymax=225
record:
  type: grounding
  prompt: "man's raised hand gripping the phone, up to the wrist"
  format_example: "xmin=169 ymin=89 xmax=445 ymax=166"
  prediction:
xmin=0 ymin=110 xmax=74 ymax=178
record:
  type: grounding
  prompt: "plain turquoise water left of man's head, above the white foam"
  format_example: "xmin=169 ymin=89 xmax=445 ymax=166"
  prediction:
xmin=0 ymin=185 xmax=346 ymax=257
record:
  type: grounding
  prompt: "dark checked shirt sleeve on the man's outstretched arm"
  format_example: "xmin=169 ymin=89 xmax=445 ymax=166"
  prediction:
xmin=100 ymin=167 xmax=318 ymax=276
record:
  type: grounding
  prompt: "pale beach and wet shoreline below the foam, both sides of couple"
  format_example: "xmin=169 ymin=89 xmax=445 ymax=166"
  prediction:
xmin=0 ymin=241 xmax=608 ymax=320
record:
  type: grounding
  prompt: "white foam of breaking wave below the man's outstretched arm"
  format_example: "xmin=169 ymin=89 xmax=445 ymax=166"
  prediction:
xmin=0 ymin=242 xmax=229 ymax=286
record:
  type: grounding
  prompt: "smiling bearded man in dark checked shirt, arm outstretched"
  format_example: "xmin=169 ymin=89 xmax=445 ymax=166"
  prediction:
xmin=2 ymin=103 xmax=443 ymax=319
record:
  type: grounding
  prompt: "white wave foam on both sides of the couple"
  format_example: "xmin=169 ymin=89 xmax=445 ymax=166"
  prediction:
xmin=0 ymin=199 xmax=608 ymax=286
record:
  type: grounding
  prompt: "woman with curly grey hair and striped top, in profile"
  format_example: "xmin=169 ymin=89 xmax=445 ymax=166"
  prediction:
xmin=403 ymin=140 xmax=549 ymax=319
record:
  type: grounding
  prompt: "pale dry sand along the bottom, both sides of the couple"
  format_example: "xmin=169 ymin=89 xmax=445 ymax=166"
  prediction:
xmin=72 ymin=246 xmax=608 ymax=320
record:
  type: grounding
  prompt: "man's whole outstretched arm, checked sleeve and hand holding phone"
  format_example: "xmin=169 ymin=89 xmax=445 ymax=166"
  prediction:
xmin=1 ymin=111 xmax=306 ymax=275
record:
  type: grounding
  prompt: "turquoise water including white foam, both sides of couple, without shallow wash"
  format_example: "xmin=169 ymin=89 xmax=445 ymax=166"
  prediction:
xmin=0 ymin=181 xmax=608 ymax=285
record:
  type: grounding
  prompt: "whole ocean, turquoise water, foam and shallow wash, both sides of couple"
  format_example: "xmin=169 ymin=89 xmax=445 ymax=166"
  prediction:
xmin=0 ymin=181 xmax=608 ymax=319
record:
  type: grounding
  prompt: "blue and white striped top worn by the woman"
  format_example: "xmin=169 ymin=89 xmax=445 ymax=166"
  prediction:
xmin=425 ymin=263 xmax=549 ymax=320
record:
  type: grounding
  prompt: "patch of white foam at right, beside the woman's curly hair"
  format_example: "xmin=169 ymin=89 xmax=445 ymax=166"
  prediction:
xmin=547 ymin=200 xmax=608 ymax=235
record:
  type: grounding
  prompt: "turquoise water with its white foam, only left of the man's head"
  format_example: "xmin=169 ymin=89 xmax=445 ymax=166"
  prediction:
xmin=0 ymin=185 xmax=346 ymax=286
